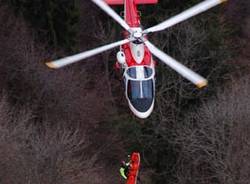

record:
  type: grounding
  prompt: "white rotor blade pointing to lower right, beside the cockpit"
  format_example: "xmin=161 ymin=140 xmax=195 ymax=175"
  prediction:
xmin=145 ymin=41 xmax=207 ymax=88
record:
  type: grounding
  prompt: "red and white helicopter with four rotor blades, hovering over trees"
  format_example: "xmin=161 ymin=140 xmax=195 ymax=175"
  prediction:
xmin=46 ymin=0 xmax=226 ymax=118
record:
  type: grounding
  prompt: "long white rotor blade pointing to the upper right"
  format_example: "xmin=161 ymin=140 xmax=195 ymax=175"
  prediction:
xmin=143 ymin=0 xmax=227 ymax=33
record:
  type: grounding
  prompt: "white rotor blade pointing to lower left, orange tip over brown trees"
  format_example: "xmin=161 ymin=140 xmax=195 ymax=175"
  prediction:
xmin=46 ymin=39 xmax=130 ymax=68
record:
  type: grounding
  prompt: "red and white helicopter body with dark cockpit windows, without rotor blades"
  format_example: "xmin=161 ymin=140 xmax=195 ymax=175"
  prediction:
xmin=117 ymin=0 xmax=155 ymax=118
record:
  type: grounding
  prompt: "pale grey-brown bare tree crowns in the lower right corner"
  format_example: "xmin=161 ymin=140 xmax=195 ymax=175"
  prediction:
xmin=174 ymin=76 xmax=250 ymax=184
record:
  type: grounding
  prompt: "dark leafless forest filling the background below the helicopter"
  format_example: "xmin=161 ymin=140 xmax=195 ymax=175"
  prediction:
xmin=0 ymin=0 xmax=250 ymax=184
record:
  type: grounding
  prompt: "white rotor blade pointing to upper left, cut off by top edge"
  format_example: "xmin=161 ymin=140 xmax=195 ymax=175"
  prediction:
xmin=92 ymin=0 xmax=130 ymax=31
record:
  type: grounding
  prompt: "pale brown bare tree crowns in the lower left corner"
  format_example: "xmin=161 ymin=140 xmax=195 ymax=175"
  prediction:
xmin=0 ymin=94 xmax=106 ymax=184
